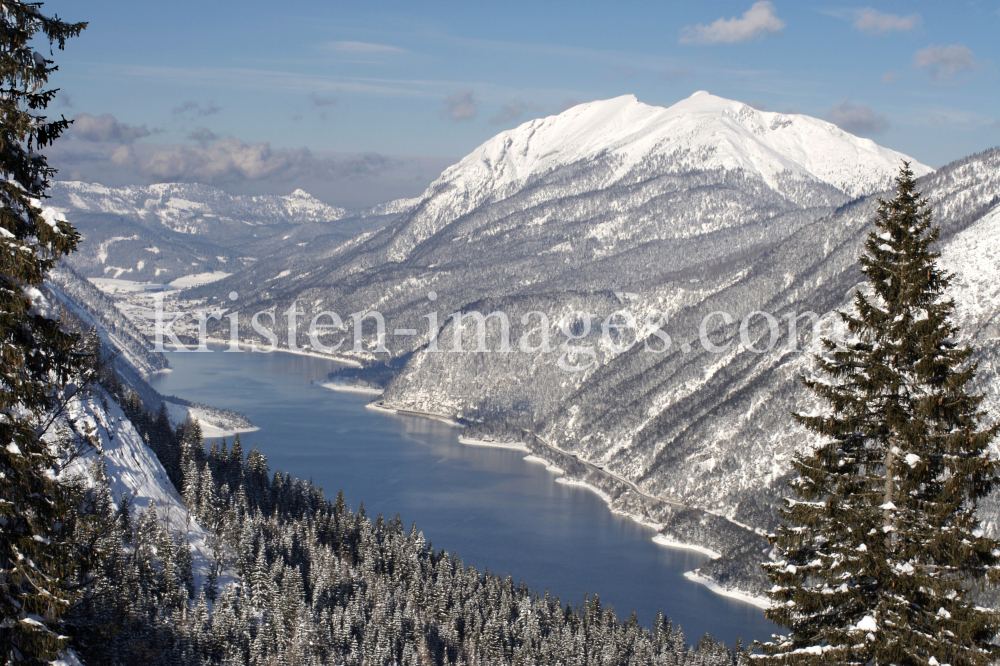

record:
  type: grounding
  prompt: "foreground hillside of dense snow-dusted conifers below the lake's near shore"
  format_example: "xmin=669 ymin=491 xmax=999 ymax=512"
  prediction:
xmin=67 ymin=382 xmax=742 ymax=666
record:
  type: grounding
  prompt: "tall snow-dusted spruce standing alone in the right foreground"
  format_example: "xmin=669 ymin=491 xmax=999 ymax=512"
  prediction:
xmin=761 ymin=163 xmax=1000 ymax=666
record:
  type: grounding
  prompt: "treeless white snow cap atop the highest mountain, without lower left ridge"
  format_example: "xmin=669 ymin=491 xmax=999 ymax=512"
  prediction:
xmin=441 ymin=91 xmax=932 ymax=197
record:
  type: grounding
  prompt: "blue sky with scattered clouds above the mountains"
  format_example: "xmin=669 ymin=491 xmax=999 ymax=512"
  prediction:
xmin=43 ymin=0 xmax=1000 ymax=207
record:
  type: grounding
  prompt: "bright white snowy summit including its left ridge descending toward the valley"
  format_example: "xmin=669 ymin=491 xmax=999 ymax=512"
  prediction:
xmin=390 ymin=91 xmax=933 ymax=260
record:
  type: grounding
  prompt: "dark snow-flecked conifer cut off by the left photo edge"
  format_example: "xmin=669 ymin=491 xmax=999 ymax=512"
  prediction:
xmin=0 ymin=0 xmax=86 ymax=663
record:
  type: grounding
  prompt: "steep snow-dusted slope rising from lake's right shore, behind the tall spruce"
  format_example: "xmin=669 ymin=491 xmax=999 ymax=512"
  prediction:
xmin=372 ymin=150 xmax=1000 ymax=592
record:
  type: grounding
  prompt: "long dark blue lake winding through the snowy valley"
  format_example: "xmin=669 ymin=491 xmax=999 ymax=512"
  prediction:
xmin=151 ymin=349 xmax=775 ymax=646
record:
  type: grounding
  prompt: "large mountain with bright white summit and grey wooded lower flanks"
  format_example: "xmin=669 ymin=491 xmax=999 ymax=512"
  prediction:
xmin=213 ymin=93 xmax=931 ymax=352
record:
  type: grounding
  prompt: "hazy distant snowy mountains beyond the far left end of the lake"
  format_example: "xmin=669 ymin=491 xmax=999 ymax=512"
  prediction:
xmin=47 ymin=181 xmax=390 ymax=283
